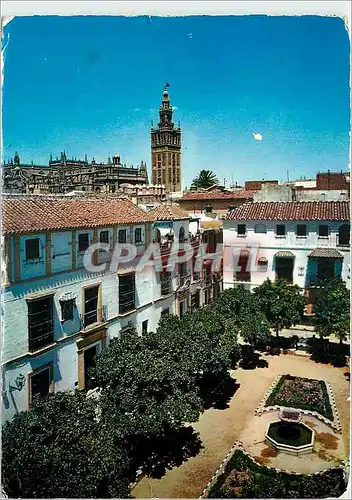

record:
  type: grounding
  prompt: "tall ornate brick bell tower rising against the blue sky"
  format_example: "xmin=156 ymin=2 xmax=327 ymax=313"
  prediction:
xmin=151 ymin=83 xmax=182 ymax=192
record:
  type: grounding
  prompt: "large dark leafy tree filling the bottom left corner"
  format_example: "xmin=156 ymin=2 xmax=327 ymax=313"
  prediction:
xmin=2 ymin=392 xmax=135 ymax=498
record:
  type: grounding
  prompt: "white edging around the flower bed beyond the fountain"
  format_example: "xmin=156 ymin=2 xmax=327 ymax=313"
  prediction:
xmin=254 ymin=374 xmax=342 ymax=434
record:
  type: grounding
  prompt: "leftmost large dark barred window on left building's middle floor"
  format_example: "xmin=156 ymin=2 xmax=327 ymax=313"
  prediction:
xmin=28 ymin=295 xmax=54 ymax=352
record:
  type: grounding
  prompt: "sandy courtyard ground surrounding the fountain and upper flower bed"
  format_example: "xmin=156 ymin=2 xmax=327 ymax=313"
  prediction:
xmin=132 ymin=354 xmax=350 ymax=498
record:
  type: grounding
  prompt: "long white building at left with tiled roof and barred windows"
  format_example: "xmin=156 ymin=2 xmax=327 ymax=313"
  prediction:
xmin=2 ymin=196 xmax=176 ymax=420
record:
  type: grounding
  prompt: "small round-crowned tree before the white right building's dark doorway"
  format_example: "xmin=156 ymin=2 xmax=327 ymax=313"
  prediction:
xmin=254 ymin=279 xmax=307 ymax=336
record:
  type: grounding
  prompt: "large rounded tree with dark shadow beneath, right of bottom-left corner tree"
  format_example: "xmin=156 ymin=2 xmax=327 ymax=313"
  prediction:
xmin=94 ymin=324 xmax=202 ymax=476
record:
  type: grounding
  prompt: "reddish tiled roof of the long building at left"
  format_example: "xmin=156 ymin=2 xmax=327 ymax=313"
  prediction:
xmin=2 ymin=196 xmax=154 ymax=233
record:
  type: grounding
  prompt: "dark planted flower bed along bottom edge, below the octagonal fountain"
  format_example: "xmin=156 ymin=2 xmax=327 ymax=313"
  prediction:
xmin=207 ymin=449 xmax=346 ymax=498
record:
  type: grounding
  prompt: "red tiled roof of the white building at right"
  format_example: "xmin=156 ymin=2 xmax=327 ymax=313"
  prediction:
xmin=226 ymin=201 xmax=350 ymax=221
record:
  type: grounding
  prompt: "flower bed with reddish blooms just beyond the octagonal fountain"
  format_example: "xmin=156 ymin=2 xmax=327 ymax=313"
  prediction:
xmin=265 ymin=375 xmax=334 ymax=422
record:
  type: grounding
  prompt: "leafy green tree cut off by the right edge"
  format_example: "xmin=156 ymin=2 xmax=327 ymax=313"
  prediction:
xmin=313 ymin=278 xmax=350 ymax=344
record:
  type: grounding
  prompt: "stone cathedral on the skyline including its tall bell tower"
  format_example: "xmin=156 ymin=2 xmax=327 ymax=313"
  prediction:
xmin=3 ymin=83 xmax=182 ymax=194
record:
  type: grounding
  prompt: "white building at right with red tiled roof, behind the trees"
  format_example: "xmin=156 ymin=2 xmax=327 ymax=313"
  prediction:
xmin=223 ymin=201 xmax=350 ymax=300
